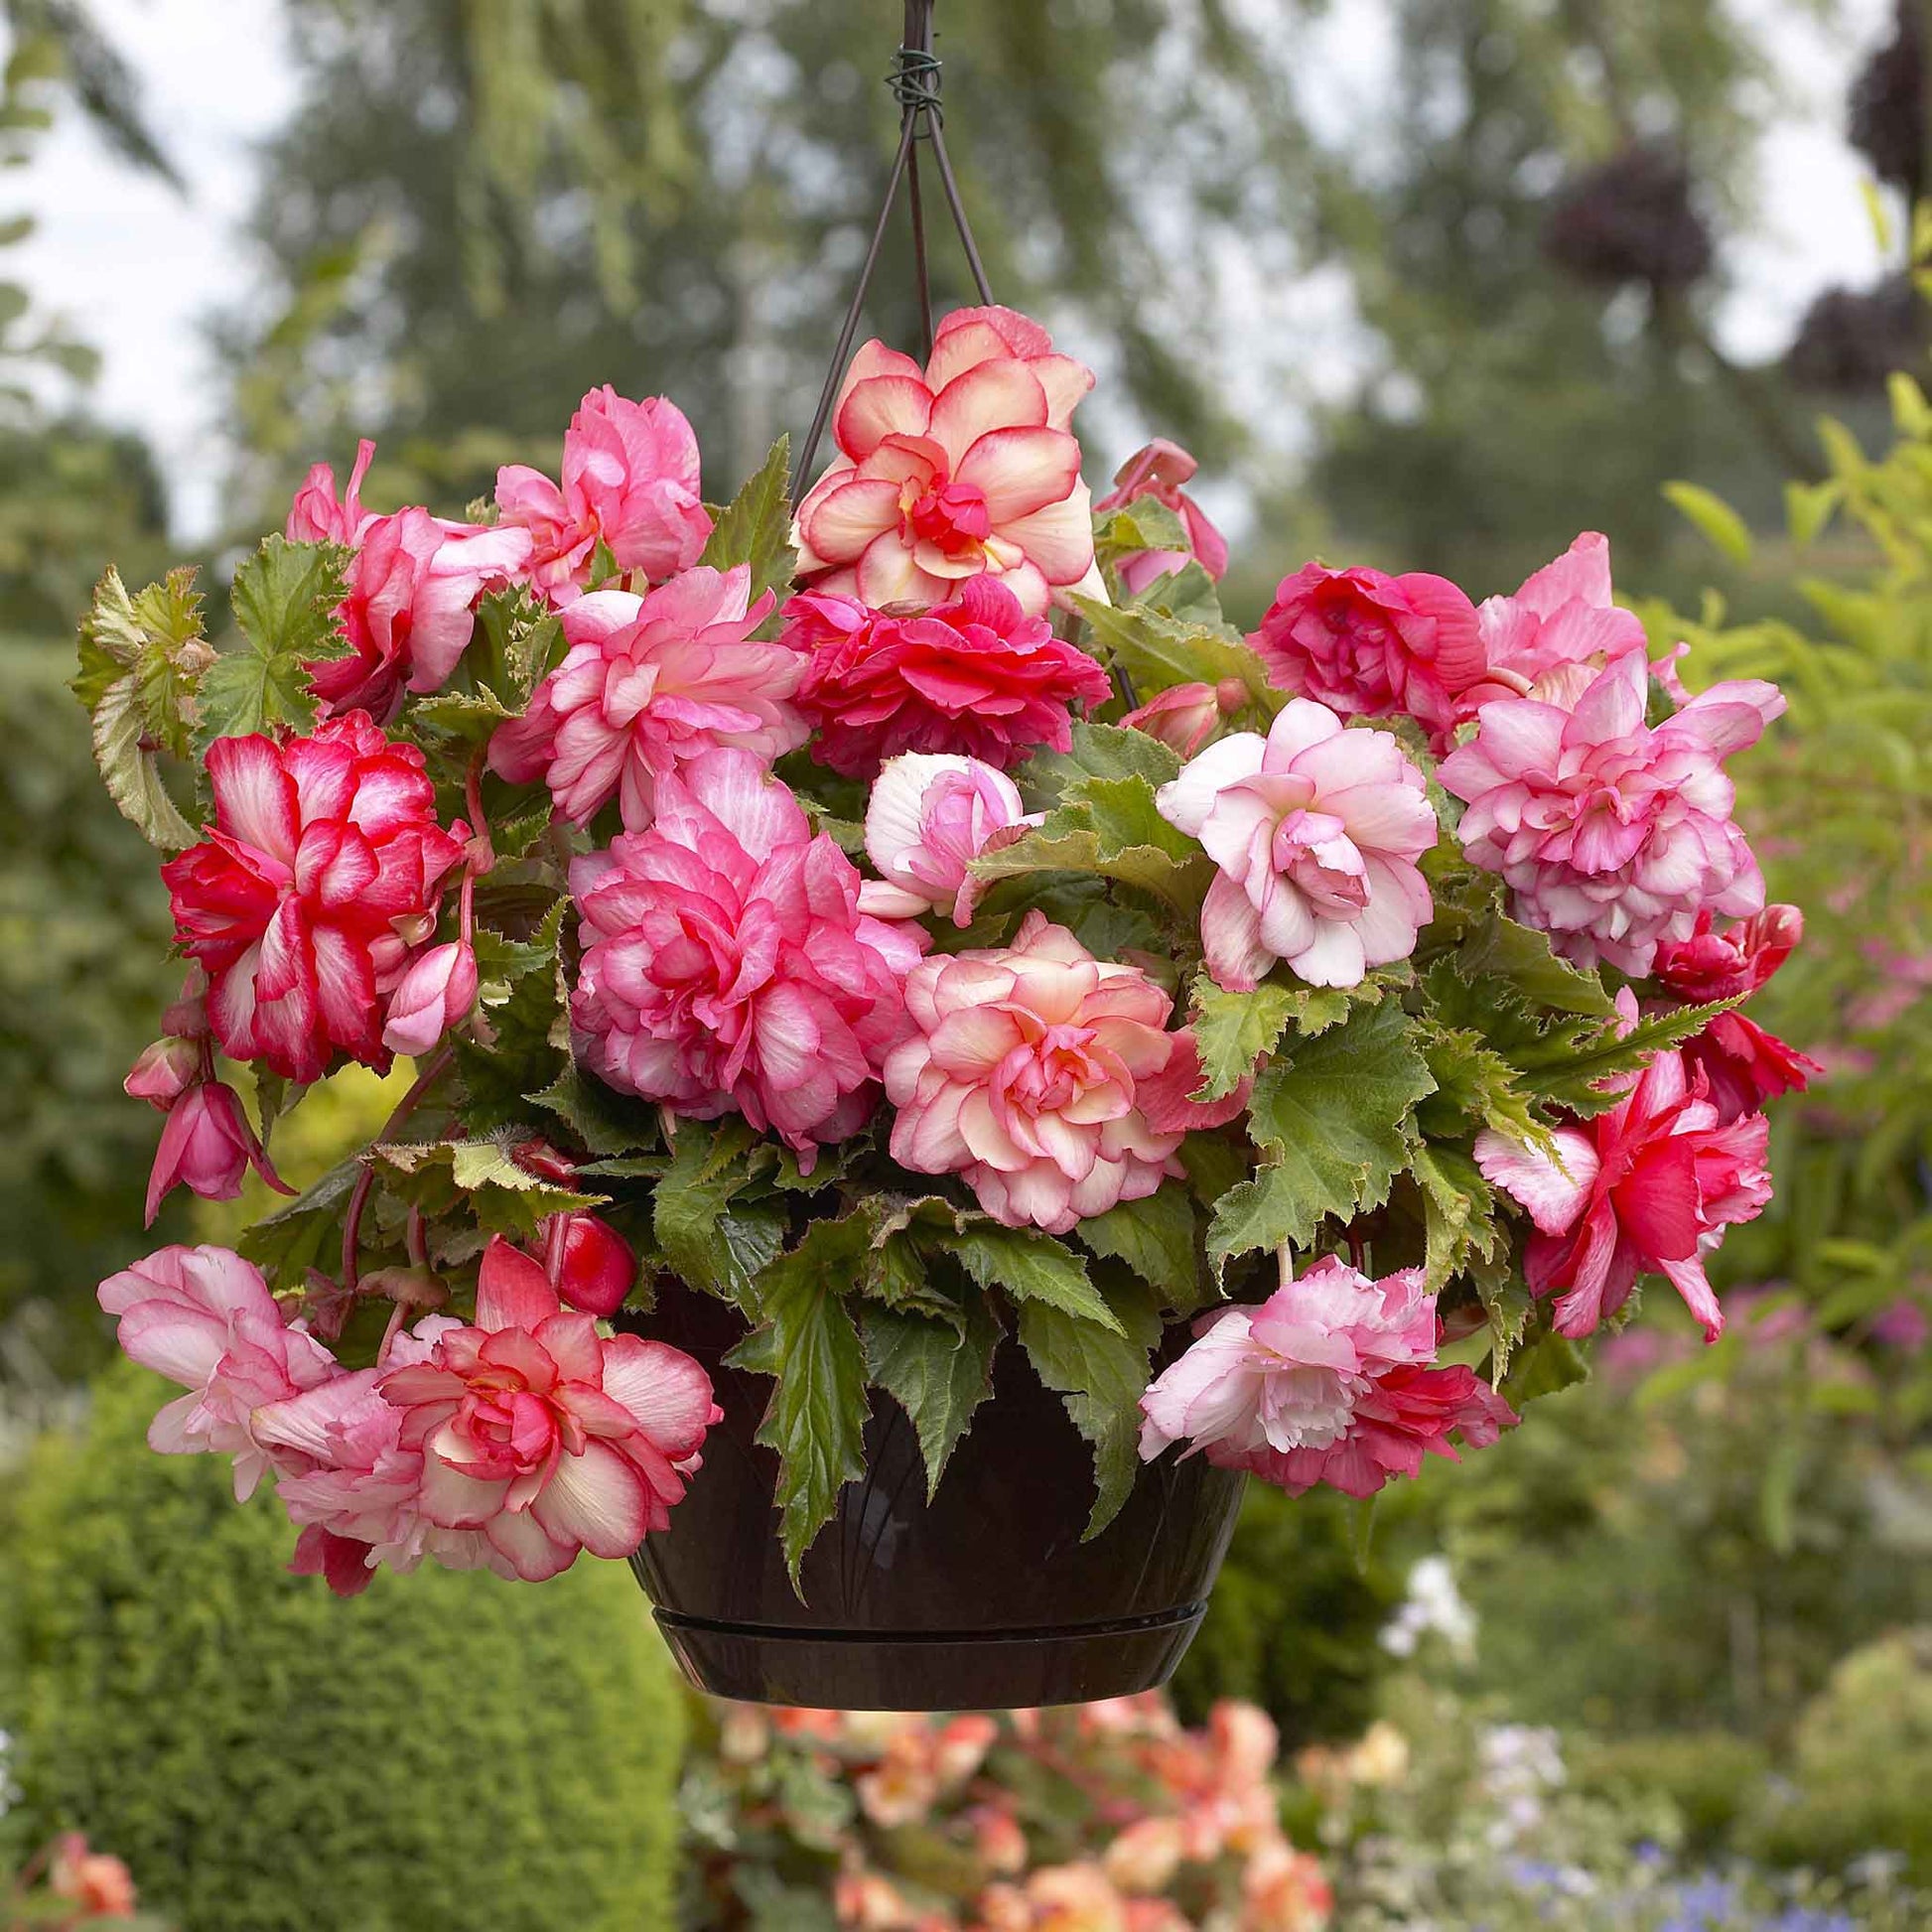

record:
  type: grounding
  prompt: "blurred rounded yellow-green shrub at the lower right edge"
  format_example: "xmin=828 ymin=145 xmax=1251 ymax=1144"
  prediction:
xmin=1752 ymin=1628 xmax=1932 ymax=1883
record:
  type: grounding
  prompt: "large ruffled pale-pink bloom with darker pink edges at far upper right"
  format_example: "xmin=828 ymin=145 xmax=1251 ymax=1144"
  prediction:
xmin=1438 ymin=651 xmax=1785 ymax=978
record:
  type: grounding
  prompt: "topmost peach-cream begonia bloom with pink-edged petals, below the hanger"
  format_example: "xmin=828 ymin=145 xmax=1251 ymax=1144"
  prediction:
xmin=796 ymin=307 xmax=1107 ymax=614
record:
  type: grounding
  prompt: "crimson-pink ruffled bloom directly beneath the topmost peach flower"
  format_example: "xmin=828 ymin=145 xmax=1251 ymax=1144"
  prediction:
xmin=782 ymin=578 xmax=1113 ymax=778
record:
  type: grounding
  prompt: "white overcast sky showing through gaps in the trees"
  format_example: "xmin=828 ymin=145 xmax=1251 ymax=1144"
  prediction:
xmin=0 ymin=0 xmax=1891 ymax=541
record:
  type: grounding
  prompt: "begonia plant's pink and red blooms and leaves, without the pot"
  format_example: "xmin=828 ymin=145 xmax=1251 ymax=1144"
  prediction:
xmin=75 ymin=307 xmax=1808 ymax=1592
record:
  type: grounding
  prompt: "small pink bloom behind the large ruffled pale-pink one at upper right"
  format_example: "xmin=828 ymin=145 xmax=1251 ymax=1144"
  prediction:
xmin=1456 ymin=529 xmax=1646 ymax=723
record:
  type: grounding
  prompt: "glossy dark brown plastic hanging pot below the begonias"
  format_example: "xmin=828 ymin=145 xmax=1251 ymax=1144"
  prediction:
xmin=629 ymin=1291 xmax=1242 ymax=1710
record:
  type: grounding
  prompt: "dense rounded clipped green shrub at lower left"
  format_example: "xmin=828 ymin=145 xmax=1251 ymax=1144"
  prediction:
xmin=0 ymin=1368 xmax=684 ymax=1932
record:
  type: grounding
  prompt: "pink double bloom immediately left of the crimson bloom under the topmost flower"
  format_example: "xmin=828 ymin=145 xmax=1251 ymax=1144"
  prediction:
xmin=488 ymin=564 xmax=809 ymax=831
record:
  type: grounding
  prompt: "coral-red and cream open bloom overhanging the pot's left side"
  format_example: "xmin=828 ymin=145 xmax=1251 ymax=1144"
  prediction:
xmin=362 ymin=1234 xmax=719 ymax=1583
